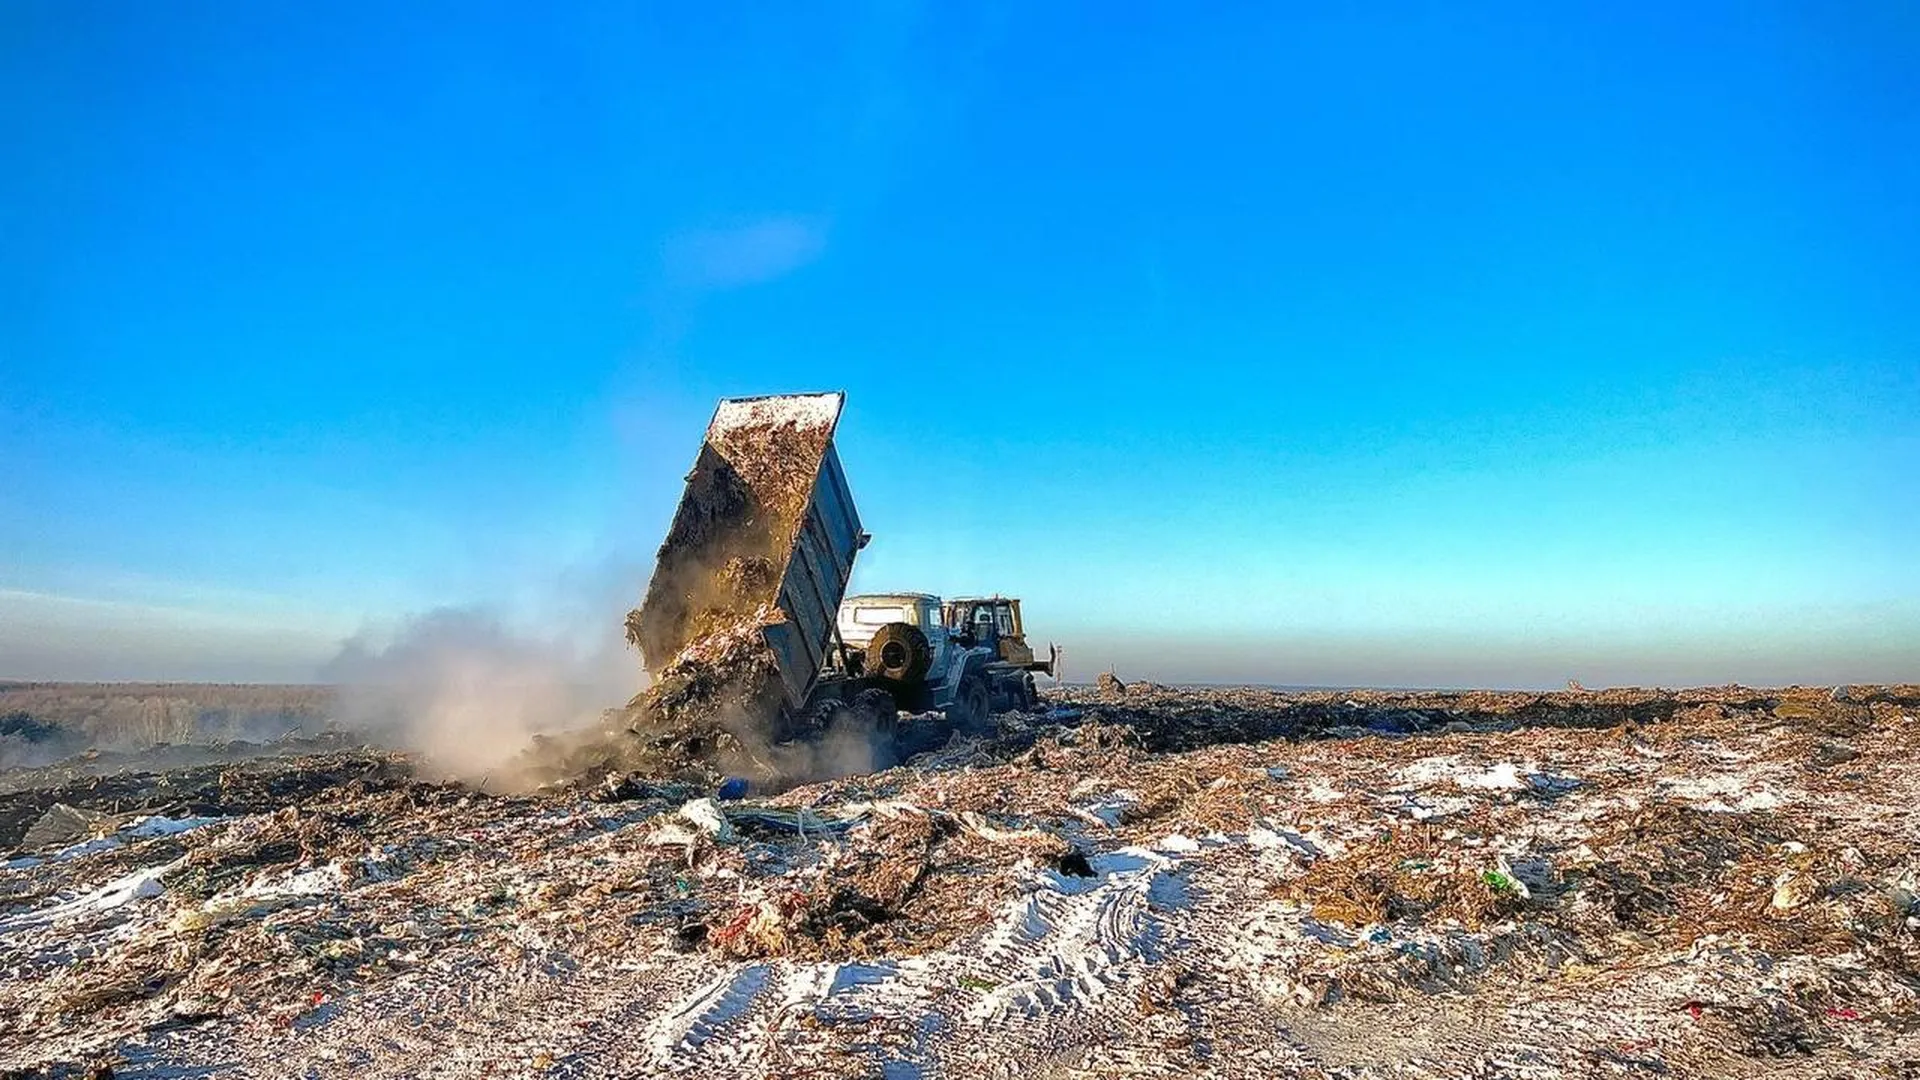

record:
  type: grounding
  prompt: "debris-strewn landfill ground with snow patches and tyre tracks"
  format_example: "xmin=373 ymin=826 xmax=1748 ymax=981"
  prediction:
xmin=0 ymin=684 xmax=1920 ymax=1078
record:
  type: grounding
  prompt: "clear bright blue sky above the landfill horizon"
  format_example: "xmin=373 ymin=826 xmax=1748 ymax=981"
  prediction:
xmin=0 ymin=0 xmax=1920 ymax=684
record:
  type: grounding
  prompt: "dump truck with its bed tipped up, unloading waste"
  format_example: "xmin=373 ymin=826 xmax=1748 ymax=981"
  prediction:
xmin=628 ymin=392 xmax=1035 ymax=768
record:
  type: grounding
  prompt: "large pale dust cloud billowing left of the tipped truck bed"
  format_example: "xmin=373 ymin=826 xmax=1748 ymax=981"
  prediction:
xmin=321 ymin=607 xmax=643 ymax=790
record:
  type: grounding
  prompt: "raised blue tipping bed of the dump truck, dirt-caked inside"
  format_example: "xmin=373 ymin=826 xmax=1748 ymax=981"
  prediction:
xmin=628 ymin=392 xmax=864 ymax=709
